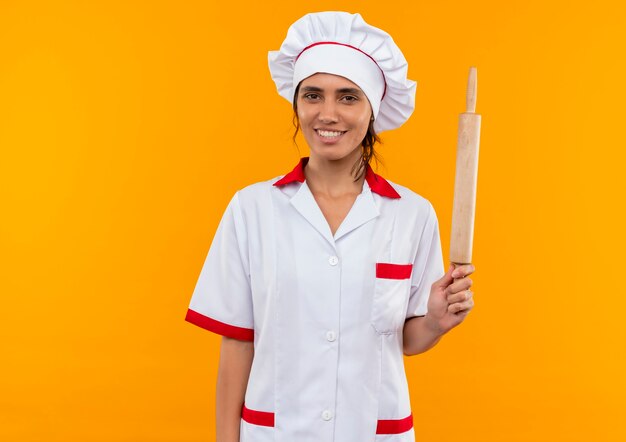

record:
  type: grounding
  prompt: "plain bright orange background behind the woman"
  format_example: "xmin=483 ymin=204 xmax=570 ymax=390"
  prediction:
xmin=0 ymin=0 xmax=626 ymax=442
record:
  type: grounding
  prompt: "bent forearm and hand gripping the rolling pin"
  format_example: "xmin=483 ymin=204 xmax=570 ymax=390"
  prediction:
xmin=403 ymin=264 xmax=474 ymax=356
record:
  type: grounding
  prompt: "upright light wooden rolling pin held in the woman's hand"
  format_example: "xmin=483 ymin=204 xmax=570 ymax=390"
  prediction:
xmin=450 ymin=67 xmax=480 ymax=274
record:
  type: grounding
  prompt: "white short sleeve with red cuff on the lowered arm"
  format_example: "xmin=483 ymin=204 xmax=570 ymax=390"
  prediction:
xmin=185 ymin=193 xmax=254 ymax=341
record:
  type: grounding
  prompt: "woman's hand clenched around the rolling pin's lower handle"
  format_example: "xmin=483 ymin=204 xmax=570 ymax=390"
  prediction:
xmin=425 ymin=264 xmax=475 ymax=334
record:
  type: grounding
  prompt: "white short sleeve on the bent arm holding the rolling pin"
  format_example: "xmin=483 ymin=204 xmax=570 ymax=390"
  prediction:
xmin=406 ymin=203 xmax=445 ymax=319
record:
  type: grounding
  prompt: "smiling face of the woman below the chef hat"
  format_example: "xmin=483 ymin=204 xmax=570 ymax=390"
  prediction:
xmin=297 ymin=73 xmax=372 ymax=160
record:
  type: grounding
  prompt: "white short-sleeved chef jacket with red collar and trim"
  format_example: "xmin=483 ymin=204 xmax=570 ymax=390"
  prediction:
xmin=186 ymin=157 xmax=445 ymax=442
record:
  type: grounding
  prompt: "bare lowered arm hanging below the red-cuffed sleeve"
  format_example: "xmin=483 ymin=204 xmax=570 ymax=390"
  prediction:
xmin=215 ymin=336 xmax=254 ymax=442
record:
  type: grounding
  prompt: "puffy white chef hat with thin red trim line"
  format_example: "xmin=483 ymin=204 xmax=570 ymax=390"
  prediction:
xmin=268 ymin=11 xmax=417 ymax=133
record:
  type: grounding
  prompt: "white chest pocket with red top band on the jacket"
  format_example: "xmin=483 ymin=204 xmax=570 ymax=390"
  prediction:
xmin=372 ymin=262 xmax=413 ymax=334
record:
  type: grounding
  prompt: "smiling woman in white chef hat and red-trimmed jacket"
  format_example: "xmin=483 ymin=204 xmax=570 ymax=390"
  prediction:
xmin=186 ymin=12 xmax=474 ymax=442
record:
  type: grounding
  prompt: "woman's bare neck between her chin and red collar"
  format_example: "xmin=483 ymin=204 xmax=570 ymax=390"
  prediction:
xmin=304 ymin=149 xmax=365 ymax=197
